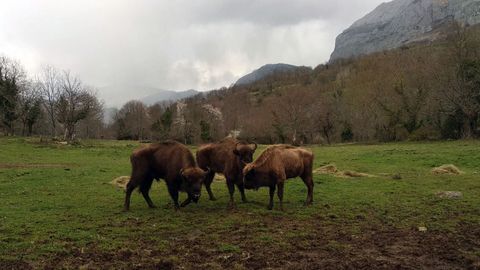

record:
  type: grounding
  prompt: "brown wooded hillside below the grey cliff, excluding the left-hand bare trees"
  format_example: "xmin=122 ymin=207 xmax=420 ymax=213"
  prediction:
xmin=129 ymin=26 xmax=480 ymax=144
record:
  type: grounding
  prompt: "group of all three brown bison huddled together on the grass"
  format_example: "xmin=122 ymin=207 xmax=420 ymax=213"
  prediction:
xmin=124 ymin=138 xmax=313 ymax=211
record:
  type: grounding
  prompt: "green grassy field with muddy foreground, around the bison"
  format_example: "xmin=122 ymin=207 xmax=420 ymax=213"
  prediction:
xmin=0 ymin=138 xmax=480 ymax=269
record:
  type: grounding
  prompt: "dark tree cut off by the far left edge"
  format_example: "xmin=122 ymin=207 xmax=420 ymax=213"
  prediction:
xmin=0 ymin=56 xmax=26 ymax=135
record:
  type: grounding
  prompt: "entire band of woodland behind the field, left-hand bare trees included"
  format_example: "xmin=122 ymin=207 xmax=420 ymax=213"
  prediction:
xmin=0 ymin=25 xmax=480 ymax=144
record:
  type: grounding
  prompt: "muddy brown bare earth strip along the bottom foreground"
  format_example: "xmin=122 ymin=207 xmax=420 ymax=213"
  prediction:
xmin=31 ymin=217 xmax=480 ymax=269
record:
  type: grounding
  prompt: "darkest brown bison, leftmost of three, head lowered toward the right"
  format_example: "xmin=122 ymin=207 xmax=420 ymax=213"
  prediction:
xmin=124 ymin=141 xmax=209 ymax=210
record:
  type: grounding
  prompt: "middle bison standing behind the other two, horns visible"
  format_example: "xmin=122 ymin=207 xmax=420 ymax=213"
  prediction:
xmin=197 ymin=138 xmax=257 ymax=205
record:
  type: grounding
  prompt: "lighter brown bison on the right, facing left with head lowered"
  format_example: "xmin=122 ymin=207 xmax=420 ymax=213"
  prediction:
xmin=243 ymin=145 xmax=313 ymax=210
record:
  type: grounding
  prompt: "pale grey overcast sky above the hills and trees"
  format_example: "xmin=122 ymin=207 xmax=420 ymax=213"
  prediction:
xmin=0 ymin=0 xmax=383 ymax=104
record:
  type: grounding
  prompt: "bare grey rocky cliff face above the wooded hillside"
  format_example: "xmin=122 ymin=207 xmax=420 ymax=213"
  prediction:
xmin=330 ymin=0 xmax=480 ymax=61
